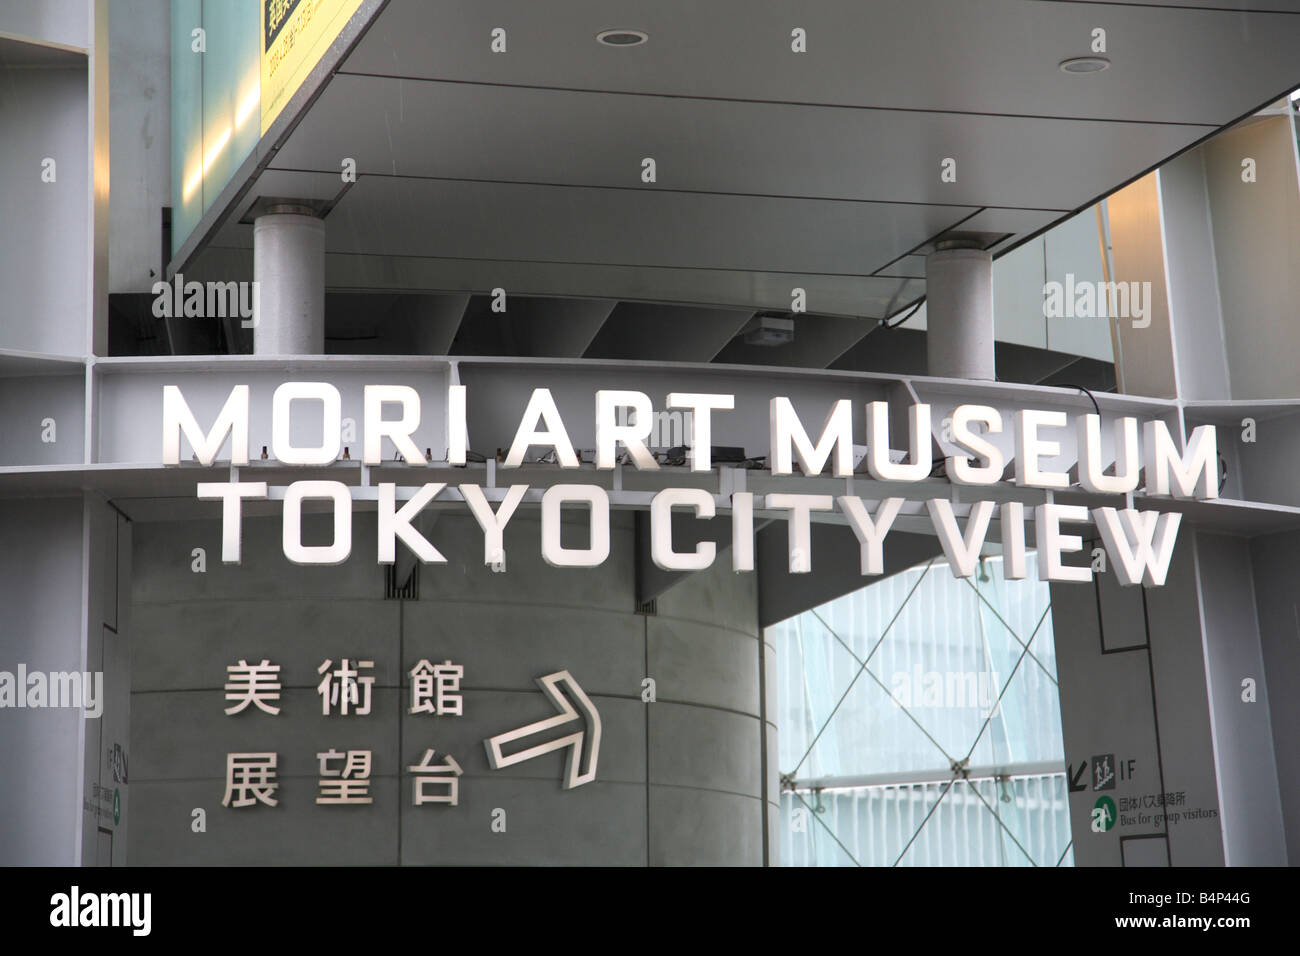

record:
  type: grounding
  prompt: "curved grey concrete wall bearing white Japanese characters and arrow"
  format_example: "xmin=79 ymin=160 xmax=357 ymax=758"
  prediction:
xmin=129 ymin=510 xmax=776 ymax=865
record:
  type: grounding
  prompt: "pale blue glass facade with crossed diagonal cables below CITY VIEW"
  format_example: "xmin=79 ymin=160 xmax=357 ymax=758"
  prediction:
xmin=767 ymin=553 xmax=1071 ymax=866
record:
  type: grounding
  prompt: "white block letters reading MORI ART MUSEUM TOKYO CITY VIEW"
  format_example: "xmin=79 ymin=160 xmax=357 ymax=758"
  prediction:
xmin=163 ymin=381 xmax=1218 ymax=587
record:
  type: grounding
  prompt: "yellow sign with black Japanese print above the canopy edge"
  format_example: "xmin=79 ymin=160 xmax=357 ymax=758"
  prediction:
xmin=261 ymin=0 xmax=361 ymax=133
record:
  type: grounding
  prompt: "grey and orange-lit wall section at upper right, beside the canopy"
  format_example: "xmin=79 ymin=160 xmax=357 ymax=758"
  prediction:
xmin=1108 ymin=113 xmax=1300 ymax=399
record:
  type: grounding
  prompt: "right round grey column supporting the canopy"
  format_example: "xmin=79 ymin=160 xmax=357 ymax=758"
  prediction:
xmin=926 ymin=239 xmax=997 ymax=381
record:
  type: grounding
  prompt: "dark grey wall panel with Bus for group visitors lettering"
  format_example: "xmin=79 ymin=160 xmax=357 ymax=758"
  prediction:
xmin=1052 ymin=535 xmax=1225 ymax=866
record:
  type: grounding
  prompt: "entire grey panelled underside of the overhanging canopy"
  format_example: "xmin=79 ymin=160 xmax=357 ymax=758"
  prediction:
xmin=177 ymin=0 xmax=1300 ymax=329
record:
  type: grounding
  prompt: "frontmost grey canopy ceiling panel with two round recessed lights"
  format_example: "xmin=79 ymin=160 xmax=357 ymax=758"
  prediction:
xmin=343 ymin=0 xmax=1300 ymax=126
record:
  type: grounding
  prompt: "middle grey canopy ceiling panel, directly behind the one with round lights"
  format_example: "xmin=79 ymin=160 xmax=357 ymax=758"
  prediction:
xmin=273 ymin=75 xmax=1213 ymax=211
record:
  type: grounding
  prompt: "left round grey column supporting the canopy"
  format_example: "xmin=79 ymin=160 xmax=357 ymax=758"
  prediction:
xmin=252 ymin=204 xmax=325 ymax=355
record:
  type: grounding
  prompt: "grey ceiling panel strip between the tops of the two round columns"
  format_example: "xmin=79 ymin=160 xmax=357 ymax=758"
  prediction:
xmin=325 ymin=176 xmax=976 ymax=274
